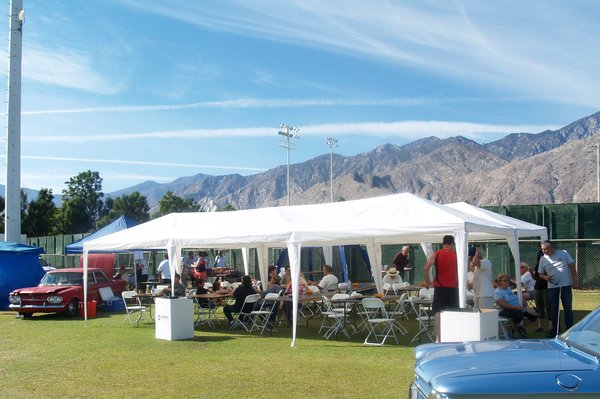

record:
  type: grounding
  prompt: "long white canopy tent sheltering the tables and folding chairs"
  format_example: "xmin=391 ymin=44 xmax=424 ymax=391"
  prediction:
xmin=83 ymin=193 xmax=545 ymax=346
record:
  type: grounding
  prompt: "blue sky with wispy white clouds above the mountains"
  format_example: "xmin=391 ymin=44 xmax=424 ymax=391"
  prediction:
xmin=0 ymin=0 xmax=600 ymax=194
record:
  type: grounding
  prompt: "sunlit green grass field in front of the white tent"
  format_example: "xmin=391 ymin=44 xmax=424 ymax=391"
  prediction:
xmin=0 ymin=291 xmax=600 ymax=399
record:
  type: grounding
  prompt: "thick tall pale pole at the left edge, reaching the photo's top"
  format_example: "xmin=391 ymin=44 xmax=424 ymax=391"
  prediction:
xmin=4 ymin=0 xmax=25 ymax=242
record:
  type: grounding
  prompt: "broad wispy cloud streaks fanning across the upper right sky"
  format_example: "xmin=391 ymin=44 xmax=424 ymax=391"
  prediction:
xmin=128 ymin=0 xmax=600 ymax=106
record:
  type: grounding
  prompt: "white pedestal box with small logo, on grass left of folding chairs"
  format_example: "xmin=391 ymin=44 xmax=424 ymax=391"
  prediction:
xmin=155 ymin=298 xmax=194 ymax=341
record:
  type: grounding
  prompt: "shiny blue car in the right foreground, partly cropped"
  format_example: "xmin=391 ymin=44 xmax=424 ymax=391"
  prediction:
xmin=409 ymin=307 xmax=600 ymax=399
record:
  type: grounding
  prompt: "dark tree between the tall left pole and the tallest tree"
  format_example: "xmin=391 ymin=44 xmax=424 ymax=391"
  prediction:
xmin=21 ymin=188 xmax=56 ymax=237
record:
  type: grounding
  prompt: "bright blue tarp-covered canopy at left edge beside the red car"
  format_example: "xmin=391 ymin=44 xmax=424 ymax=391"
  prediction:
xmin=0 ymin=241 xmax=45 ymax=310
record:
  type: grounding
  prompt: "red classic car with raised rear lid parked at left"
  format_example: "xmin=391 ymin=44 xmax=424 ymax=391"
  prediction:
xmin=8 ymin=268 xmax=127 ymax=317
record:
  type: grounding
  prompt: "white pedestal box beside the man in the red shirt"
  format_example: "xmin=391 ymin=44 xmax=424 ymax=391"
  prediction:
xmin=440 ymin=309 xmax=498 ymax=342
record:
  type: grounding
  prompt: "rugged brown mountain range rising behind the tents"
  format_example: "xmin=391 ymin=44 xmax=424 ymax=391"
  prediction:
xmin=5 ymin=112 xmax=600 ymax=210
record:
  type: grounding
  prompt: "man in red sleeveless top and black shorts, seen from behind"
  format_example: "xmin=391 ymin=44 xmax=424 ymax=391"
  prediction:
xmin=423 ymin=235 xmax=458 ymax=342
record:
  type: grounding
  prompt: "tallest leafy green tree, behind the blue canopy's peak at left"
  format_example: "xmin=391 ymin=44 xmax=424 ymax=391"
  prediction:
xmin=56 ymin=170 xmax=104 ymax=234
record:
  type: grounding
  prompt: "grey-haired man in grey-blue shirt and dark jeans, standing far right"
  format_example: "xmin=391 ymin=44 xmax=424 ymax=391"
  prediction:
xmin=538 ymin=240 xmax=578 ymax=337
